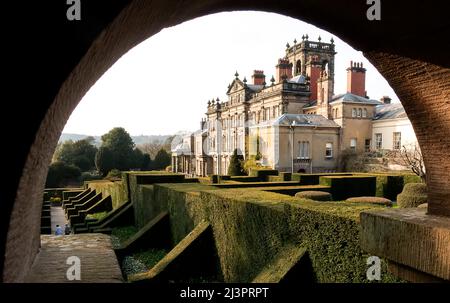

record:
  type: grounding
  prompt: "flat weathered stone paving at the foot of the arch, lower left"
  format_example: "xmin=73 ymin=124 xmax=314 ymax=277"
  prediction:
xmin=26 ymin=235 xmax=123 ymax=283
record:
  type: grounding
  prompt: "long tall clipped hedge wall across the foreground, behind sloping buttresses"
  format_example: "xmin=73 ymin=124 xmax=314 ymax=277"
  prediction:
xmin=148 ymin=184 xmax=399 ymax=282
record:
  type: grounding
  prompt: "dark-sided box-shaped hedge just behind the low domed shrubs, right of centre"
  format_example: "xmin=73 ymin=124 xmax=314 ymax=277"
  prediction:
xmin=320 ymin=176 xmax=376 ymax=201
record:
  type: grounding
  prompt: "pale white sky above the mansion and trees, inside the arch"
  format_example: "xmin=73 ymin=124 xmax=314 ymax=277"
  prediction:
xmin=63 ymin=11 xmax=398 ymax=136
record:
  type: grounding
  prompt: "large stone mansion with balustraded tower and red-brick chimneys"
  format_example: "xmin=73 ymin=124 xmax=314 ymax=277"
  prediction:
xmin=172 ymin=35 xmax=415 ymax=176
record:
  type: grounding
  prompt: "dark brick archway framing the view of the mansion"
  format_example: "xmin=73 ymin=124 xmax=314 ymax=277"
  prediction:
xmin=0 ymin=0 xmax=450 ymax=282
